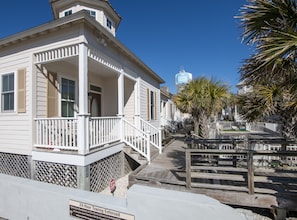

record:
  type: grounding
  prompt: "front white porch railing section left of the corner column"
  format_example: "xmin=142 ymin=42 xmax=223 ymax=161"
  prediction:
xmin=35 ymin=118 xmax=77 ymax=150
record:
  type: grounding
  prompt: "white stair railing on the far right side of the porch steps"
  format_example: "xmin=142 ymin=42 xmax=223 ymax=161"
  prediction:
xmin=140 ymin=118 xmax=162 ymax=153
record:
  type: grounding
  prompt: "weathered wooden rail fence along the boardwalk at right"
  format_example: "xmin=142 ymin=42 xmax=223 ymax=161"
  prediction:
xmin=186 ymin=139 xmax=297 ymax=194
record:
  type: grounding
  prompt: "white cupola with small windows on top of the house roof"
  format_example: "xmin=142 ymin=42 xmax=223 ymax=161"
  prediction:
xmin=50 ymin=0 xmax=121 ymax=36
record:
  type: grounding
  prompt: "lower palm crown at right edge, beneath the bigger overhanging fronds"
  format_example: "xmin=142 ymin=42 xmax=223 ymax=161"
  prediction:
xmin=237 ymin=84 xmax=297 ymax=138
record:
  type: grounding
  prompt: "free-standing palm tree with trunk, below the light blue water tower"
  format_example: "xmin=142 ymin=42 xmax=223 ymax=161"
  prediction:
xmin=174 ymin=77 xmax=229 ymax=138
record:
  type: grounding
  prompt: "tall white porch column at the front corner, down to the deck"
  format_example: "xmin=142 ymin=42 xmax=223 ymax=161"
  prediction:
xmin=77 ymin=43 xmax=90 ymax=154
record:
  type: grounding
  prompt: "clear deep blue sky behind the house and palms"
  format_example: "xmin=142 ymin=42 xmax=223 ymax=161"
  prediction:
xmin=0 ymin=0 xmax=252 ymax=93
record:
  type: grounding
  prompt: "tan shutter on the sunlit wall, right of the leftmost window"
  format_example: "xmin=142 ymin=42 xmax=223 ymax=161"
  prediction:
xmin=17 ymin=69 xmax=26 ymax=113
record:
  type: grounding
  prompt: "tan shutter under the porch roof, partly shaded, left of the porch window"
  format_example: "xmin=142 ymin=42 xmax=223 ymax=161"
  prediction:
xmin=47 ymin=73 xmax=58 ymax=118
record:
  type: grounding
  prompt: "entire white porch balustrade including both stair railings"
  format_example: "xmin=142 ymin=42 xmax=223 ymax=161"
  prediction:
xmin=35 ymin=117 xmax=162 ymax=161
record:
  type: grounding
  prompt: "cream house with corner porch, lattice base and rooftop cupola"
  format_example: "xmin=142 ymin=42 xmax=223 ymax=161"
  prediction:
xmin=0 ymin=0 xmax=164 ymax=191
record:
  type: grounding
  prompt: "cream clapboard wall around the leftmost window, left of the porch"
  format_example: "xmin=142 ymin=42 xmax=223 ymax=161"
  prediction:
xmin=0 ymin=52 xmax=32 ymax=154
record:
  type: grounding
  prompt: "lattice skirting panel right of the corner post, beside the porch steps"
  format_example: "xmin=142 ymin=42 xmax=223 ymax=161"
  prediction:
xmin=90 ymin=152 xmax=131 ymax=192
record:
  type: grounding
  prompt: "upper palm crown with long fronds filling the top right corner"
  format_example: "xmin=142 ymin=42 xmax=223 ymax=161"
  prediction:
xmin=238 ymin=0 xmax=297 ymax=78
